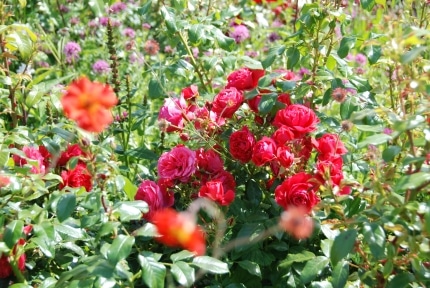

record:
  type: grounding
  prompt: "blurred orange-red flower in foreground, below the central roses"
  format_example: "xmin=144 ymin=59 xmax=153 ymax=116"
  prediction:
xmin=152 ymin=208 xmax=206 ymax=255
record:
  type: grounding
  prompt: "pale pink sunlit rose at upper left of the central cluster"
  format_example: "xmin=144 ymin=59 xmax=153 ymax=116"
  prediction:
xmin=158 ymin=97 xmax=187 ymax=132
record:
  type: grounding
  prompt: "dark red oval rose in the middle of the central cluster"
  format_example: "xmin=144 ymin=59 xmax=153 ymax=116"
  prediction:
xmin=229 ymin=126 xmax=255 ymax=163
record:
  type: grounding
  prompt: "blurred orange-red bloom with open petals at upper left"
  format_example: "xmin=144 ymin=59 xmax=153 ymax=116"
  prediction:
xmin=61 ymin=77 xmax=118 ymax=132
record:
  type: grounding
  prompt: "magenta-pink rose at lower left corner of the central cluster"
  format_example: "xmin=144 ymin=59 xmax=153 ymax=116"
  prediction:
xmin=134 ymin=180 xmax=174 ymax=220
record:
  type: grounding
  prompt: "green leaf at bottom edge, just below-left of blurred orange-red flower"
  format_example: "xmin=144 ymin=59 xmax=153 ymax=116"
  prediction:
xmin=137 ymin=255 xmax=166 ymax=288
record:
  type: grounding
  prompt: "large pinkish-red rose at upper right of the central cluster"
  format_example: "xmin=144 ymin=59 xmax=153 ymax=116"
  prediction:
xmin=273 ymin=104 xmax=320 ymax=138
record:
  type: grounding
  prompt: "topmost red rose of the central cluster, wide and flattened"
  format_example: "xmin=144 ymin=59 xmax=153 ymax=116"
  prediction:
xmin=226 ymin=68 xmax=264 ymax=90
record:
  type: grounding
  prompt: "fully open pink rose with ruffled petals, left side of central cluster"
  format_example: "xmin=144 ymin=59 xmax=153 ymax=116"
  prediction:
xmin=157 ymin=146 xmax=197 ymax=182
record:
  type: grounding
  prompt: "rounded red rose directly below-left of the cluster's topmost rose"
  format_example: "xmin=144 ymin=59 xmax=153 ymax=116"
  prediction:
xmin=212 ymin=87 xmax=244 ymax=118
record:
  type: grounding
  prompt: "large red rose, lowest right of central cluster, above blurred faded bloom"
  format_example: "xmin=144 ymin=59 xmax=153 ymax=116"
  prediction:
xmin=275 ymin=172 xmax=319 ymax=213
